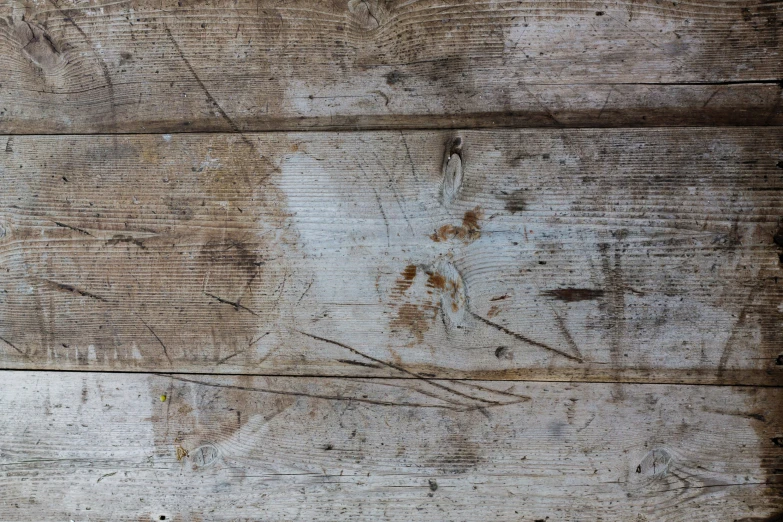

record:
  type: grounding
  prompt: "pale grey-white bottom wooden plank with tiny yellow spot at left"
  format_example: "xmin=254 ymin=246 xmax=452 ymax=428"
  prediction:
xmin=0 ymin=372 xmax=783 ymax=522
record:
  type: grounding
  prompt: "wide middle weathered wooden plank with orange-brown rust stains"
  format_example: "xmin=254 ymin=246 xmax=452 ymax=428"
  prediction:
xmin=0 ymin=128 xmax=783 ymax=384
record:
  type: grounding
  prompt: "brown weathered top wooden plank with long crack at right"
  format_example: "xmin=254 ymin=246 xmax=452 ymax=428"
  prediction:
xmin=0 ymin=0 xmax=783 ymax=134
